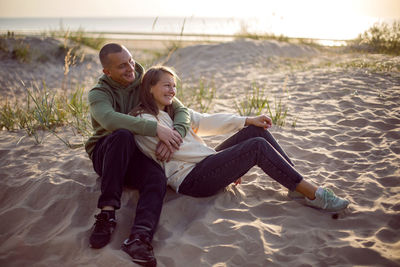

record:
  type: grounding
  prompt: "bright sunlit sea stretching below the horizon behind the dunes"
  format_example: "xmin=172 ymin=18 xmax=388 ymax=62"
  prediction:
xmin=0 ymin=17 xmax=376 ymax=45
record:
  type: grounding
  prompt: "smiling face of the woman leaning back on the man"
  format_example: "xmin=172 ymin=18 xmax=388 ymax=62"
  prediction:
xmin=150 ymin=72 xmax=176 ymax=110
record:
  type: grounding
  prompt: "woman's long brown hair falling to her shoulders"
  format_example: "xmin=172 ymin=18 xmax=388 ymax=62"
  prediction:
xmin=129 ymin=66 xmax=178 ymax=119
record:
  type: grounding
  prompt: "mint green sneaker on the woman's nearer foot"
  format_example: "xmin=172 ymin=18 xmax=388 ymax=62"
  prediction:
xmin=305 ymin=187 xmax=350 ymax=211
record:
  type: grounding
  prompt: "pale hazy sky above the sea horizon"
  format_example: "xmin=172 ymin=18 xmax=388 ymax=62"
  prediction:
xmin=0 ymin=0 xmax=400 ymax=19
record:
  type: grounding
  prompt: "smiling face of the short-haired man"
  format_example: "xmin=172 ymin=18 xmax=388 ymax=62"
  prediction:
xmin=103 ymin=48 xmax=135 ymax=86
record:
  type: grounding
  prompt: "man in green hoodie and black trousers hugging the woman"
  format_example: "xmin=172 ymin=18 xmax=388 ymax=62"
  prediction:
xmin=85 ymin=43 xmax=190 ymax=266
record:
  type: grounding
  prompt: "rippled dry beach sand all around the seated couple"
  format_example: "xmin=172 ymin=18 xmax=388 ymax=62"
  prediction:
xmin=0 ymin=36 xmax=400 ymax=267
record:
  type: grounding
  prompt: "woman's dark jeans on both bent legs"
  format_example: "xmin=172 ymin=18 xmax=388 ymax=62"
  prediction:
xmin=179 ymin=126 xmax=303 ymax=197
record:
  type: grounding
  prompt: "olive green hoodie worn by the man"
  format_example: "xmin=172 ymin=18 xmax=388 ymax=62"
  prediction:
xmin=85 ymin=63 xmax=190 ymax=158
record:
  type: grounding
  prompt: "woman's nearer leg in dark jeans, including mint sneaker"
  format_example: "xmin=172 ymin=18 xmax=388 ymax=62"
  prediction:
xmin=179 ymin=137 xmax=349 ymax=211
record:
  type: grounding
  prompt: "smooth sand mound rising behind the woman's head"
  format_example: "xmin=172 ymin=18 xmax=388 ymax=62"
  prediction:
xmin=165 ymin=39 xmax=318 ymax=78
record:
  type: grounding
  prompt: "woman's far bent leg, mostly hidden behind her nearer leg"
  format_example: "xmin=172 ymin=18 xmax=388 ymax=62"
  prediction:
xmin=215 ymin=125 xmax=294 ymax=166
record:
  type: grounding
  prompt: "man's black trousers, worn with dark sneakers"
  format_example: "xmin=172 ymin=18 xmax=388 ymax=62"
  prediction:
xmin=92 ymin=129 xmax=167 ymax=239
